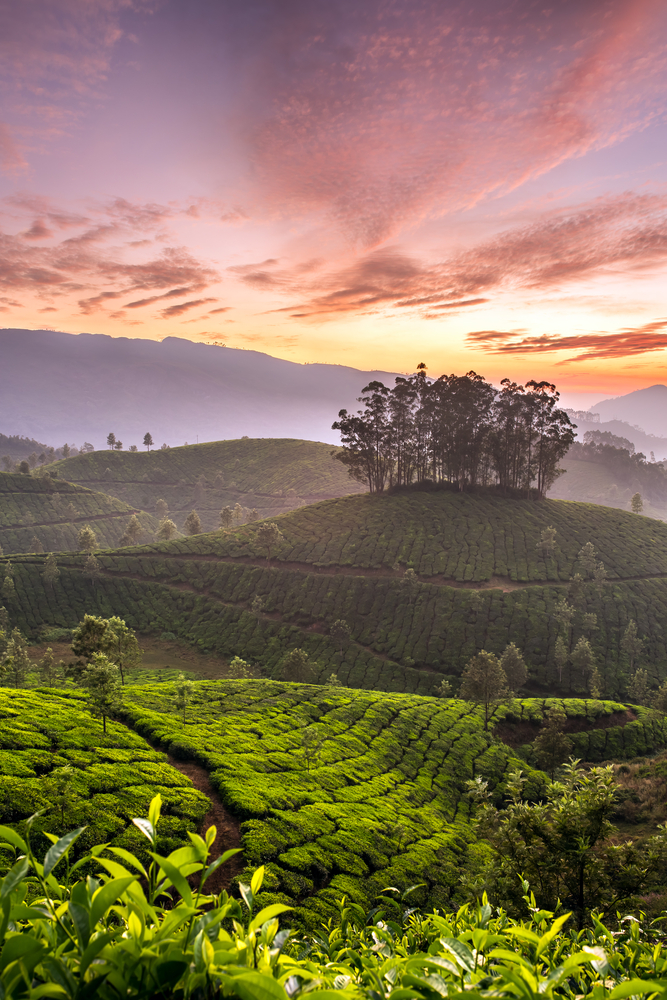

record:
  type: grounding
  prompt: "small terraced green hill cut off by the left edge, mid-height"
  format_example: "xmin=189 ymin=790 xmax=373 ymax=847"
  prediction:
xmin=0 ymin=472 xmax=158 ymax=555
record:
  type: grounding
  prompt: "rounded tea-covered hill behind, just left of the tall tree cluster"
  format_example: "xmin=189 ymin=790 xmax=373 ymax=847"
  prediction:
xmin=45 ymin=438 xmax=362 ymax=531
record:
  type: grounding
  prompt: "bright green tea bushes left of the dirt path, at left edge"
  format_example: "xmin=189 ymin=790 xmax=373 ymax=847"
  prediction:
xmin=0 ymin=688 xmax=209 ymax=850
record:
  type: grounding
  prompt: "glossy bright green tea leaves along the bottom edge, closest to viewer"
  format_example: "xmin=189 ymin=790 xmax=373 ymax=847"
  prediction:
xmin=0 ymin=796 xmax=667 ymax=1000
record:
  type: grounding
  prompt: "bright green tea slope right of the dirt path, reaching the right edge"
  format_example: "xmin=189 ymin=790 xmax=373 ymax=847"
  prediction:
xmin=125 ymin=681 xmax=664 ymax=927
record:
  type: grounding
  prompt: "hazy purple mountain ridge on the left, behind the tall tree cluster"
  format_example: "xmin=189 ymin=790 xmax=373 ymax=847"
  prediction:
xmin=0 ymin=330 xmax=395 ymax=448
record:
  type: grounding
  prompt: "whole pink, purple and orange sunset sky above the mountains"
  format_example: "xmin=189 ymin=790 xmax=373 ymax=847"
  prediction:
xmin=0 ymin=0 xmax=667 ymax=406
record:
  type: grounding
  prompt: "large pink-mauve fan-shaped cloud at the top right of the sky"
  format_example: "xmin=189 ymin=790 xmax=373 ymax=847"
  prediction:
xmin=245 ymin=0 xmax=667 ymax=247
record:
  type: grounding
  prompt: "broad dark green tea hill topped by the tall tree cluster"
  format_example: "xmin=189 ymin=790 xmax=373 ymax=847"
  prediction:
xmin=5 ymin=491 xmax=667 ymax=697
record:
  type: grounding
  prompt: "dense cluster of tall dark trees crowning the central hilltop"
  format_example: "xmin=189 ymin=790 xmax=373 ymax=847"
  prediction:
xmin=333 ymin=364 xmax=575 ymax=496
